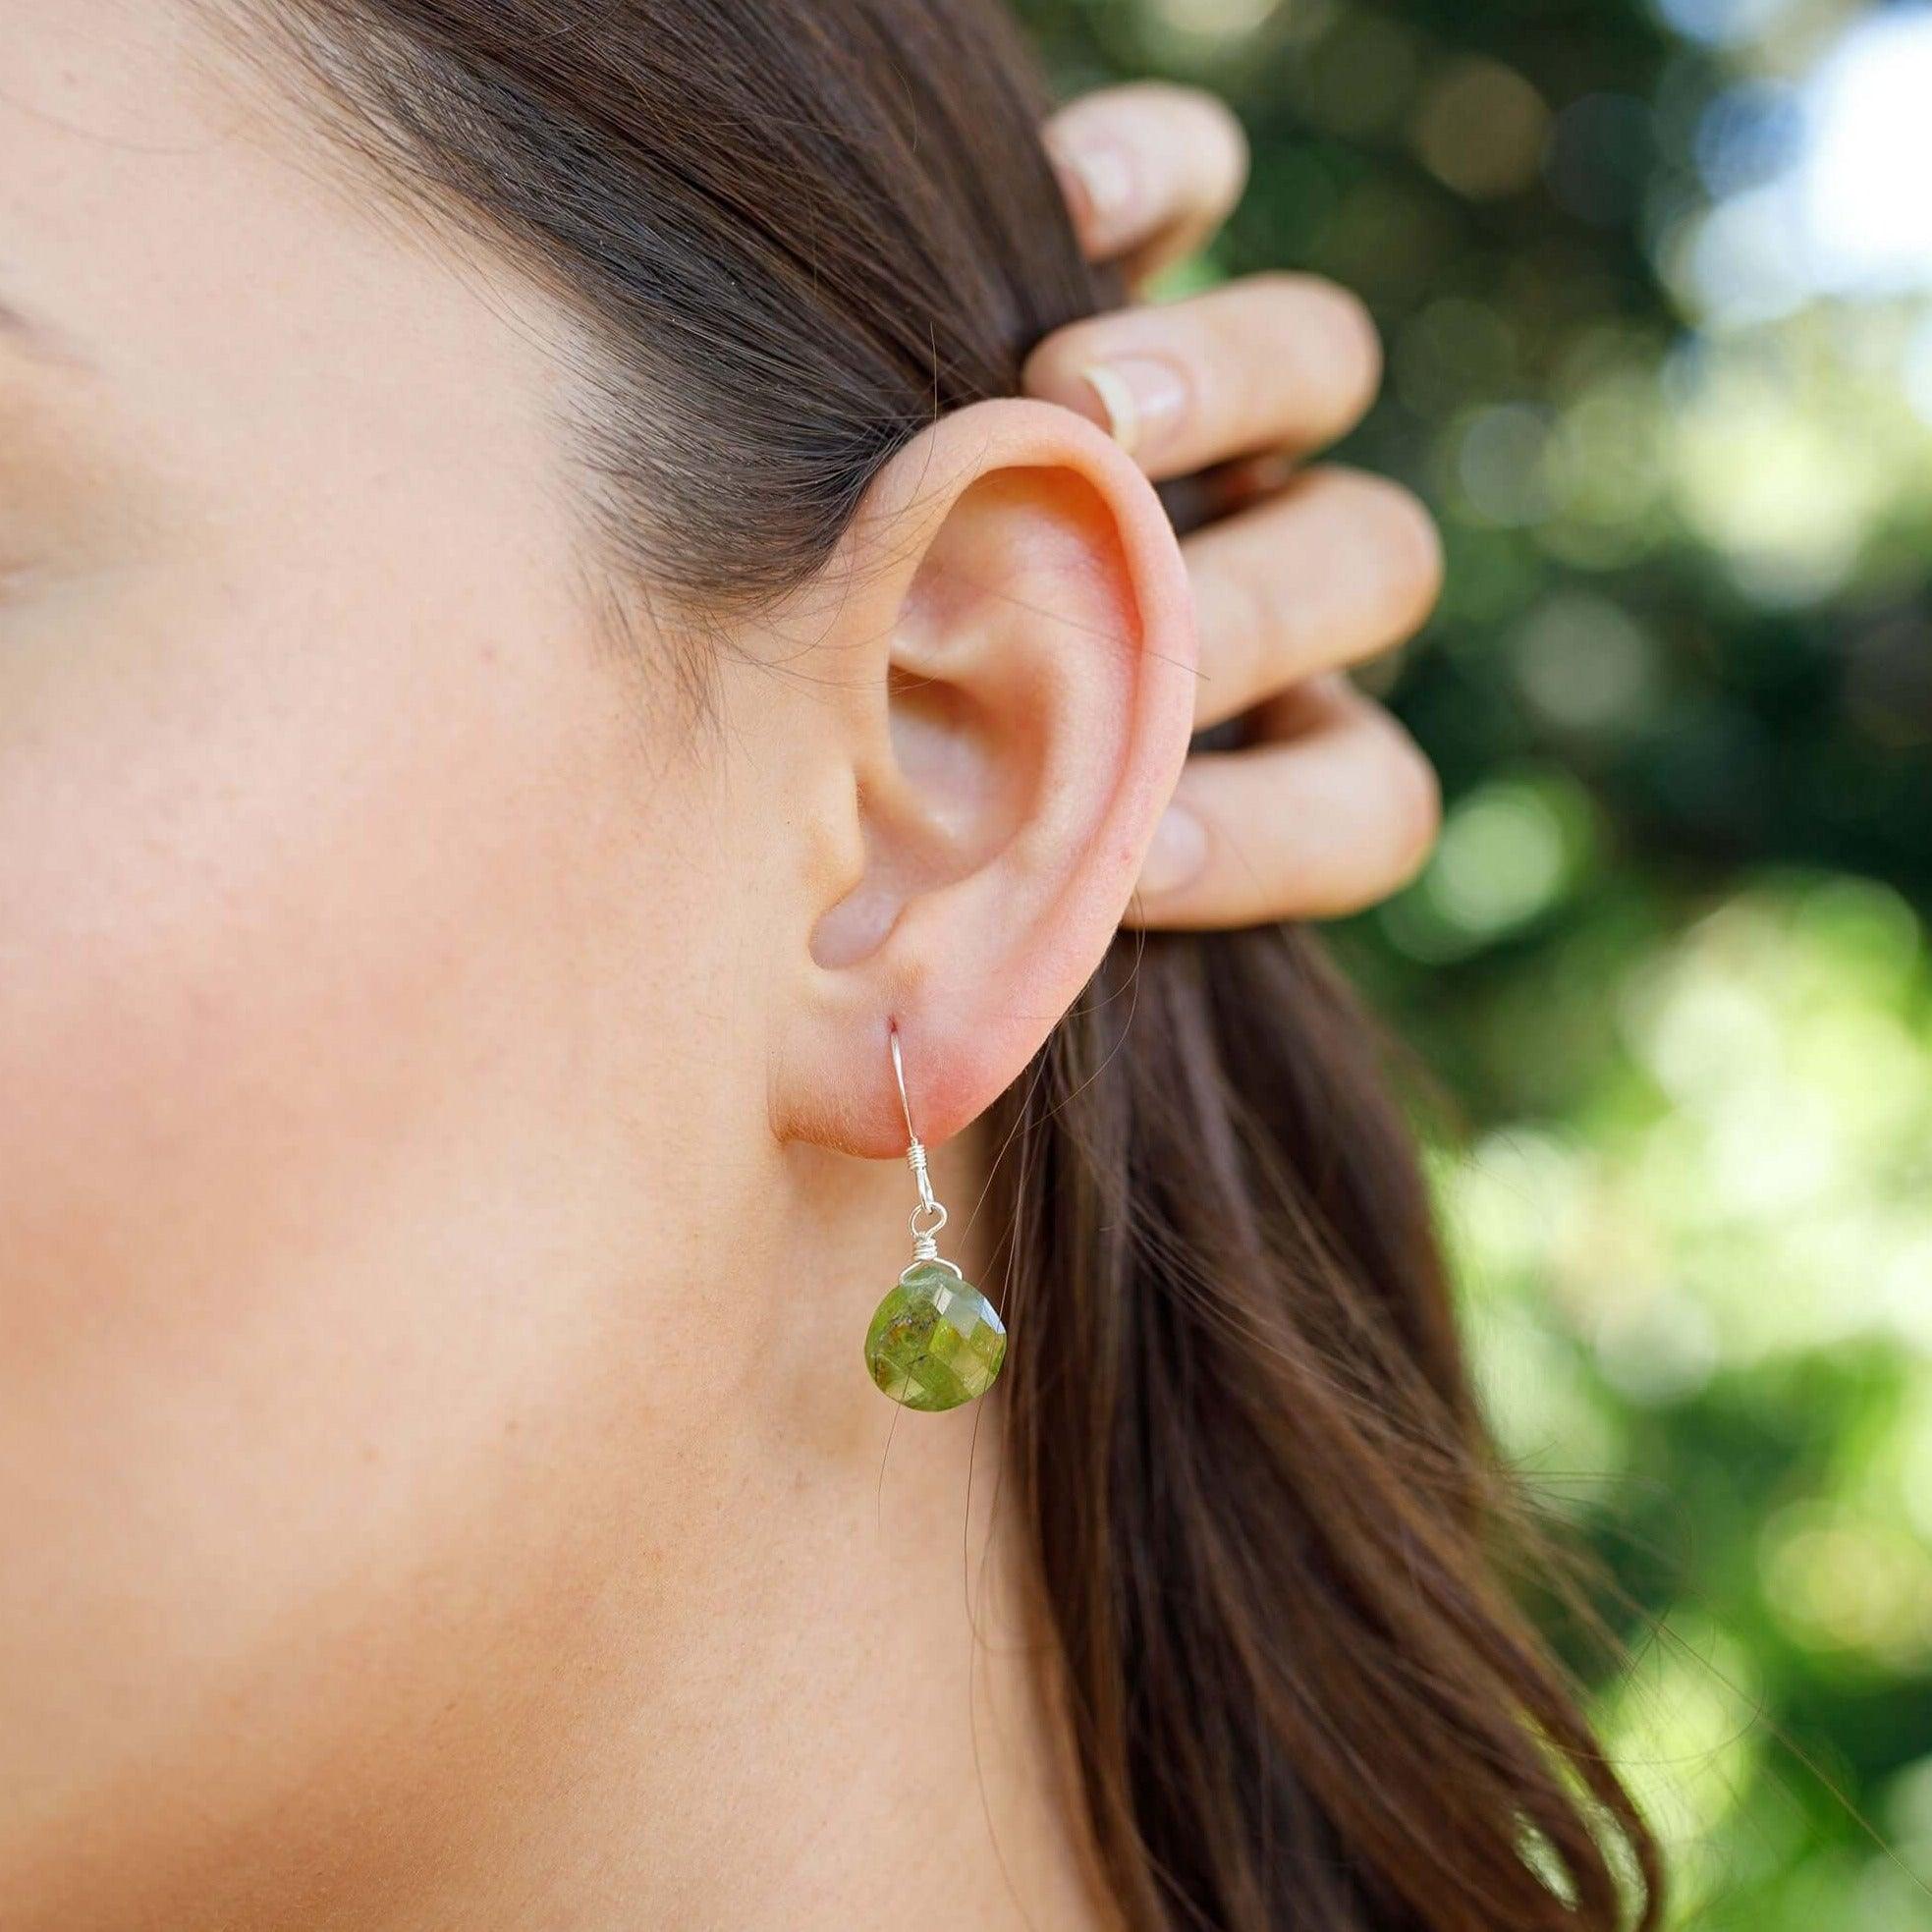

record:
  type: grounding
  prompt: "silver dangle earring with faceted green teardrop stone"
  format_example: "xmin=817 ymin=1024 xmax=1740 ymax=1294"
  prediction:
xmin=865 ymin=1022 xmax=1007 ymax=1408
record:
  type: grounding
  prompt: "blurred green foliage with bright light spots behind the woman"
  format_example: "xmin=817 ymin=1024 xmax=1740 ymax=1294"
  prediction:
xmin=1021 ymin=0 xmax=1932 ymax=1932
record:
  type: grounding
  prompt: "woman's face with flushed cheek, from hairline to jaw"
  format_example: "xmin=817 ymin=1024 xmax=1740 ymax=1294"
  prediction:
xmin=0 ymin=0 xmax=792 ymax=1922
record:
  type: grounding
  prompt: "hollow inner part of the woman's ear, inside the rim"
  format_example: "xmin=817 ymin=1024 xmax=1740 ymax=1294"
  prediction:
xmin=811 ymin=468 xmax=1136 ymax=981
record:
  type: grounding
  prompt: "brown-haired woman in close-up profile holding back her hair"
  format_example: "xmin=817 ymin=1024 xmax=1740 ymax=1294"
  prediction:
xmin=0 ymin=0 xmax=1650 ymax=1932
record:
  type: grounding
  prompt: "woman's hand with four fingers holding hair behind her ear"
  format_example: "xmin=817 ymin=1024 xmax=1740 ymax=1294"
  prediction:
xmin=1025 ymin=85 xmax=1441 ymax=927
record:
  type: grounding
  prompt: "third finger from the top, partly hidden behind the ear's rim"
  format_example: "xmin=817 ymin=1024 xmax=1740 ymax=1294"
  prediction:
xmin=1183 ymin=468 xmax=1443 ymax=729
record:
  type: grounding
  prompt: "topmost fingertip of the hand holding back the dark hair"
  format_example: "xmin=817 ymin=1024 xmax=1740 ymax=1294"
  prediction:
xmin=1045 ymin=82 xmax=1248 ymax=274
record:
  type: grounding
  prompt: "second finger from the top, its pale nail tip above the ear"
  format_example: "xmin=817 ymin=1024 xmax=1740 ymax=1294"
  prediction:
xmin=1022 ymin=274 xmax=1381 ymax=477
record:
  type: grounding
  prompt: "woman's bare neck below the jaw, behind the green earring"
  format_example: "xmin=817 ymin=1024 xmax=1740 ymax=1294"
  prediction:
xmin=68 ymin=1147 xmax=1111 ymax=1932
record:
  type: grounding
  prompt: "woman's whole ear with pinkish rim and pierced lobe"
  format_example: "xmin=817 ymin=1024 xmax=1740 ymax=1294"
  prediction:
xmin=771 ymin=400 xmax=1194 ymax=1157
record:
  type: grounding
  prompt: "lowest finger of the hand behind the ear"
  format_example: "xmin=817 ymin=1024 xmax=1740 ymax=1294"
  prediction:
xmin=1125 ymin=676 xmax=1441 ymax=929
